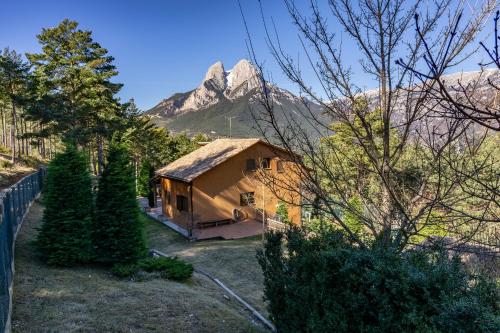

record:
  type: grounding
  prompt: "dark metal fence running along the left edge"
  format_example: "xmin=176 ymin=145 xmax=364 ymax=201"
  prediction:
xmin=0 ymin=169 xmax=45 ymax=332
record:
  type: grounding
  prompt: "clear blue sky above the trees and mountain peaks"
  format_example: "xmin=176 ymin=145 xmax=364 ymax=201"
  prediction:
xmin=0 ymin=0 xmax=492 ymax=109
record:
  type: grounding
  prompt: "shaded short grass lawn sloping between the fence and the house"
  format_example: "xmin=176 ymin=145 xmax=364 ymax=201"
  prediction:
xmin=12 ymin=203 xmax=263 ymax=332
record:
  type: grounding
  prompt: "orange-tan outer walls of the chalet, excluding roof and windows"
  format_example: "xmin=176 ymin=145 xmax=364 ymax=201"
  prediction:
xmin=161 ymin=143 xmax=301 ymax=229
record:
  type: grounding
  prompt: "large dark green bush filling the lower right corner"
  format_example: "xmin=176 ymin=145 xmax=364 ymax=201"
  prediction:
xmin=257 ymin=228 xmax=500 ymax=333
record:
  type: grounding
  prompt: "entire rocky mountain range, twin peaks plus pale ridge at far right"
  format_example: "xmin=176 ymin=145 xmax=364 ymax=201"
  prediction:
xmin=146 ymin=60 xmax=500 ymax=137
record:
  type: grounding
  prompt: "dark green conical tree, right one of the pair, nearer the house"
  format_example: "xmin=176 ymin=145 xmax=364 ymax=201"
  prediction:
xmin=92 ymin=142 xmax=146 ymax=264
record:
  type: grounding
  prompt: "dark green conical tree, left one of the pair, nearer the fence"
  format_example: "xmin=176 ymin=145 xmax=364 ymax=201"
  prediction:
xmin=37 ymin=145 xmax=93 ymax=266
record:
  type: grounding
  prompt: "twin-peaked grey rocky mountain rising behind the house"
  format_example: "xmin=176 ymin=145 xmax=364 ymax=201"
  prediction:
xmin=146 ymin=59 xmax=320 ymax=137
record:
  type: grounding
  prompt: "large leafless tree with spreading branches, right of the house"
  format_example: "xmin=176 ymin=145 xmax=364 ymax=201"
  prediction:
xmin=241 ymin=0 xmax=499 ymax=249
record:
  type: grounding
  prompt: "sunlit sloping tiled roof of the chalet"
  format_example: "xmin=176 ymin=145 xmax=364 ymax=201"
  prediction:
xmin=156 ymin=139 xmax=261 ymax=182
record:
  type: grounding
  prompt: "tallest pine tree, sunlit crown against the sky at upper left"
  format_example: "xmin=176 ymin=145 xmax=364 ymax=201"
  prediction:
xmin=26 ymin=19 xmax=122 ymax=166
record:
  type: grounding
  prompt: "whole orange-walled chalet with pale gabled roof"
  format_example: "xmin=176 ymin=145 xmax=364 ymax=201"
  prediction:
xmin=156 ymin=139 xmax=301 ymax=239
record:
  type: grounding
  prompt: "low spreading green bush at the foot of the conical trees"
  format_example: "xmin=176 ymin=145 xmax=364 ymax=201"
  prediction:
xmin=139 ymin=257 xmax=193 ymax=281
